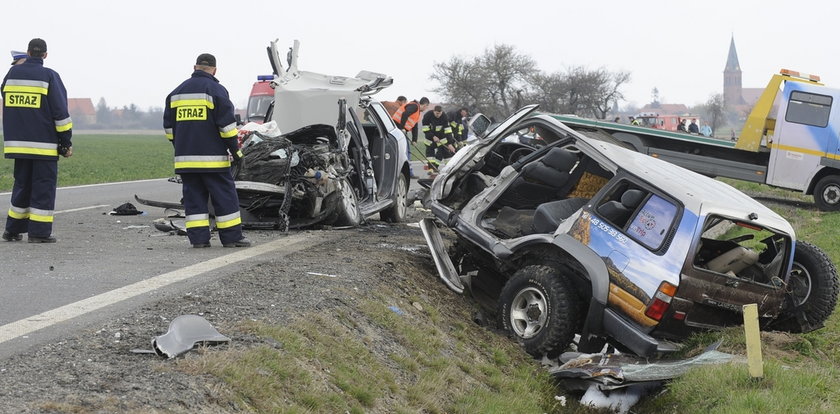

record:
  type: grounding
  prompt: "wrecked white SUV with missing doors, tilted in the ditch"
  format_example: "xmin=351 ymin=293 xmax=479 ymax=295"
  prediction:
xmin=421 ymin=105 xmax=838 ymax=357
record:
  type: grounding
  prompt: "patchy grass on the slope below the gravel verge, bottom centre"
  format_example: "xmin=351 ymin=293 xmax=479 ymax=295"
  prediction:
xmin=178 ymin=288 xmax=557 ymax=413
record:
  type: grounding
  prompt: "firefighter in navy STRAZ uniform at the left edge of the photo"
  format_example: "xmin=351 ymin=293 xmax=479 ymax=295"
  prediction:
xmin=0 ymin=39 xmax=73 ymax=243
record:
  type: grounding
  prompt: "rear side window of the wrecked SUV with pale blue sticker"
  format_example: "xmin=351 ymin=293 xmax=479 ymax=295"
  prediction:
xmin=596 ymin=181 xmax=679 ymax=250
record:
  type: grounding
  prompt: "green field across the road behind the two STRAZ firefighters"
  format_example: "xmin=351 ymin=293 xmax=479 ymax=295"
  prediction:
xmin=0 ymin=134 xmax=174 ymax=191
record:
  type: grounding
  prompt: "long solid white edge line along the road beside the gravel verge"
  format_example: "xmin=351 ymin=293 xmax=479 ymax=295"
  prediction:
xmin=0 ymin=233 xmax=324 ymax=344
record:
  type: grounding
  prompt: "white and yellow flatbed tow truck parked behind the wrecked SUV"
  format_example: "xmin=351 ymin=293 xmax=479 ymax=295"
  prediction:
xmin=554 ymin=69 xmax=840 ymax=211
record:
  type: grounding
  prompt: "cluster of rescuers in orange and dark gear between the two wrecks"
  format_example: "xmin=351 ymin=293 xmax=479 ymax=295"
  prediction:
xmin=391 ymin=96 xmax=470 ymax=178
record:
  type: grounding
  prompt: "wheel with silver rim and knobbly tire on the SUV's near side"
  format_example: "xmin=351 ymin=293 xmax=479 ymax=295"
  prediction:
xmin=498 ymin=265 xmax=578 ymax=358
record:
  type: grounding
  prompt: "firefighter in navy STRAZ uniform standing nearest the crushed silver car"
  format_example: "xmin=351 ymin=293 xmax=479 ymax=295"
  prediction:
xmin=163 ymin=53 xmax=251 ymax=247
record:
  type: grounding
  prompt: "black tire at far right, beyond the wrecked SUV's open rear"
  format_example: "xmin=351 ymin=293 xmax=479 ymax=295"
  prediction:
xmin=770 ymin=241 xmax=838 ymax=332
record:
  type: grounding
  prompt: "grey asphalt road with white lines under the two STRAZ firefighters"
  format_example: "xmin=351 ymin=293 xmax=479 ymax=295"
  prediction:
xmin=0 ymin=179 xmax=324 ymax=357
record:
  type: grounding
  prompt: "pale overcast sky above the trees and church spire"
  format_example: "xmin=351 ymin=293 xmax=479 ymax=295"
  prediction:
xmin=6 ymin=0 xmax=840 ymax=110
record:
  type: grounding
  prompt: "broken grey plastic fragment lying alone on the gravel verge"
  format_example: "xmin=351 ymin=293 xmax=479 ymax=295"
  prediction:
xmin=152 ymin=315 xmax=230 ymax=358
